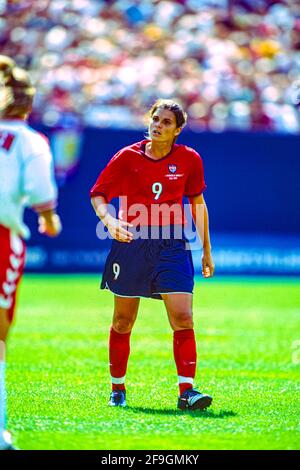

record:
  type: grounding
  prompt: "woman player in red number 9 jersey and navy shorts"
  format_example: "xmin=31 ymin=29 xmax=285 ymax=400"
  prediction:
xmin=90 ymin=100 xmax=214 ymax=410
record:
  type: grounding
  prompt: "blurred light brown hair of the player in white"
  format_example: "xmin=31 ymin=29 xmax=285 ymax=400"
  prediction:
xmin=0 ymin=55 xmax=35 ymax=117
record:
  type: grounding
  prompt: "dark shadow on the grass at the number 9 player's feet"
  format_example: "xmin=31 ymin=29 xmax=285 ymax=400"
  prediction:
xmin=124 ymin=405 xmax=237 ymax=419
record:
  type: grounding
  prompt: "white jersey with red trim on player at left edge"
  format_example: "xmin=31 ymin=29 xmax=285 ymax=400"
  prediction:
xmin=0 ymin=120 xmax=57 ymax=238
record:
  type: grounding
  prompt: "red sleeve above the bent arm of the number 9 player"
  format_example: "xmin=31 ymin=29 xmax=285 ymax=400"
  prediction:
xmin=90 ymin=149 xmax=126 ymax=202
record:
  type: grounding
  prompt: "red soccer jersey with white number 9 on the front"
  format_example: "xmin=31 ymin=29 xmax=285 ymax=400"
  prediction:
xmin=90 ymin=140 xmax=206 ymax=225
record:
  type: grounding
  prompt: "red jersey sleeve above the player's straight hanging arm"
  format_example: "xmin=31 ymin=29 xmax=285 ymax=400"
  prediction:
xmin=184 ymin=149 xmax=206 ymax=197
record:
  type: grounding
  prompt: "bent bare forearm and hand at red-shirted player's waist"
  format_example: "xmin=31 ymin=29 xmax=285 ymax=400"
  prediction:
xmin=91 ymin=196 xmax=133 ymax=243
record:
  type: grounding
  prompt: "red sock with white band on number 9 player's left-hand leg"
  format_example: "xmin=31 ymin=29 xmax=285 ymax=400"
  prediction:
xmin=109 ymin=327 xmax=131 ymax=390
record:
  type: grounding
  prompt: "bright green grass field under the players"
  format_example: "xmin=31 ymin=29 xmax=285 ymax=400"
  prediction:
xmin=7 ymin=275 xmax=300 ymax=450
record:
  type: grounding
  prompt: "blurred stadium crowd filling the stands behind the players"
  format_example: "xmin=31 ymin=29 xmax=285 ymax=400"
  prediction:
xmin=0 ymin=0 xmax=300 ymax=133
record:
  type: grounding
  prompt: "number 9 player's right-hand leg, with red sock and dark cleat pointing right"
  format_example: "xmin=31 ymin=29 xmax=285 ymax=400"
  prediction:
xmin=162 ymin=293 xmax=212 ymax=410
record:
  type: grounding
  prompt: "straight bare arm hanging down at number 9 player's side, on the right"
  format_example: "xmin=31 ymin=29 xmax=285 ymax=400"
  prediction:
xmin=189 ymin=194 xmax=215 ymax=277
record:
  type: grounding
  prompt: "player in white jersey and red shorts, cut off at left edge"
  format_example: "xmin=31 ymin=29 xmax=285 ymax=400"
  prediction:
xmin=0 ymin=56 xmax=61 ymax=450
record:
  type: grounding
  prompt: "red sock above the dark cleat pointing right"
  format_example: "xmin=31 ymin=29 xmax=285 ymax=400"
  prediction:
xmin=173 ymin=329 xmax=197 ymax=395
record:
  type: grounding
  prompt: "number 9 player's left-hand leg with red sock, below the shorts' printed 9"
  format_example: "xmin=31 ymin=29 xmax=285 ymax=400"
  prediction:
xmin=109 ymin=295 xmax=140 ymax=406
